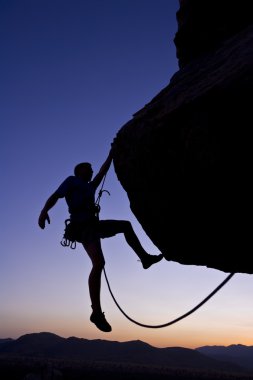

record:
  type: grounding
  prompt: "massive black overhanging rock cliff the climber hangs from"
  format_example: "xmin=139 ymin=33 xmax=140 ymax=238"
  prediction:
xmin=114 ymin=0 xmax=253 ymax=273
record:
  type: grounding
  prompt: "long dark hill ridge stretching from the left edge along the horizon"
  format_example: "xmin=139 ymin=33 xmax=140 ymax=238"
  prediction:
xmin=0 ymin=332 xmax=247 ymax=372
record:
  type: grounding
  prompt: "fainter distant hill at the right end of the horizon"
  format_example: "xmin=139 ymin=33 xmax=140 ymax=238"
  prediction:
xmin=196 ymin=344 xmax=253 ymax=370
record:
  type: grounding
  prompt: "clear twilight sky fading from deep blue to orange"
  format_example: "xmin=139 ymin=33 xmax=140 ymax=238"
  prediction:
xmin=0 ymin=0 xmax=253 ymax=348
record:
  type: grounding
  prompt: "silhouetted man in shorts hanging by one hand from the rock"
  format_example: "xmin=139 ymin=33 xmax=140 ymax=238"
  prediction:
xmin=38 ymin=145 xmax=163 ymax=332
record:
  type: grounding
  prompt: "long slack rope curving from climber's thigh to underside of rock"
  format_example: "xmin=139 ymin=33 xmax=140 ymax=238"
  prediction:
xmin=103 ymin=268 xmax=235 ymax=329
